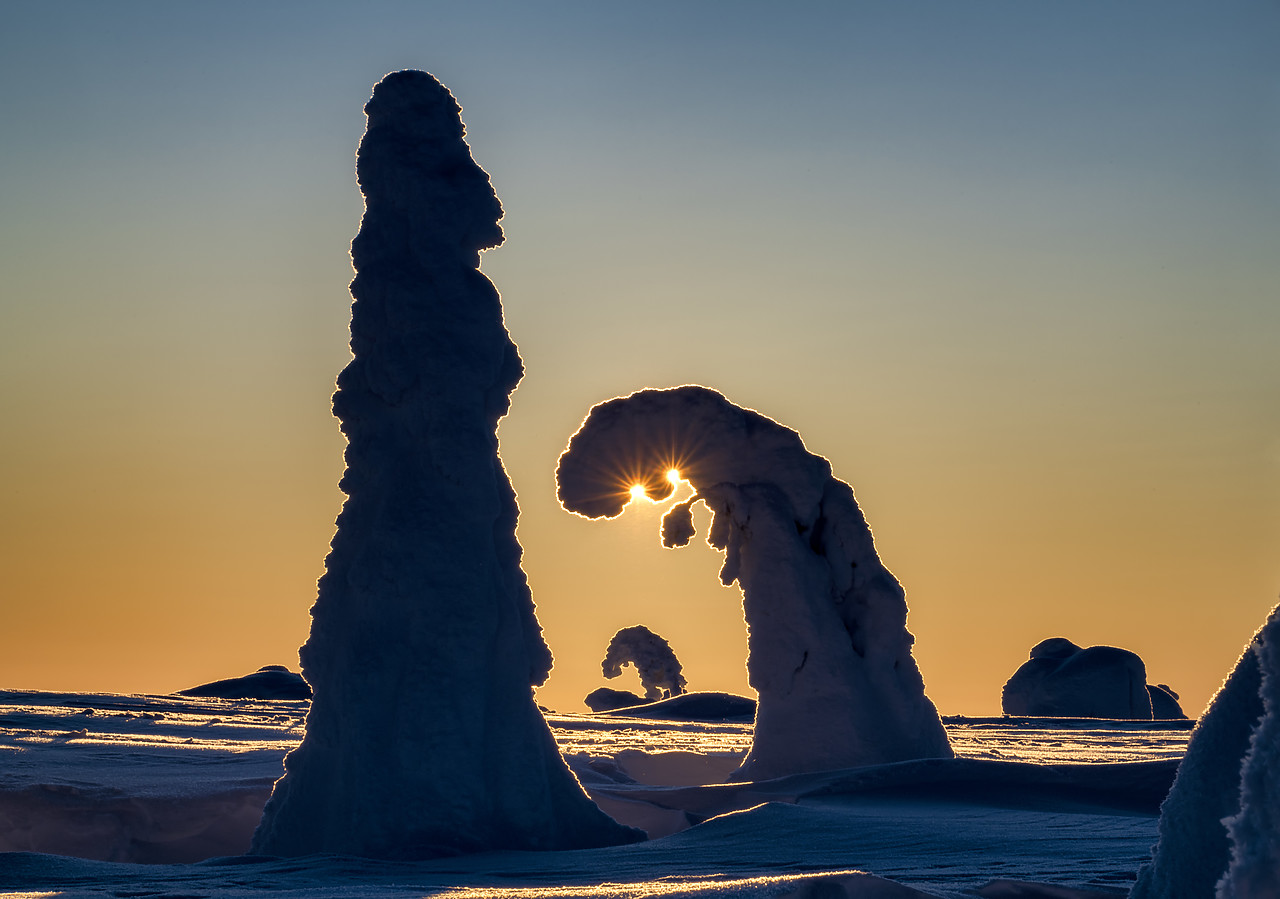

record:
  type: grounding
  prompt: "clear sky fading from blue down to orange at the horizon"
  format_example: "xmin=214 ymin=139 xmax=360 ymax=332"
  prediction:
xmin=0 ymin=0 xmax=1280 ymax=715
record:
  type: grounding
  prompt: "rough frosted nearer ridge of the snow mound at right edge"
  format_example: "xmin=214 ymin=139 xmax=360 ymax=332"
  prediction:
xmin=1217 ymin=607 xmax=1280 ymax=899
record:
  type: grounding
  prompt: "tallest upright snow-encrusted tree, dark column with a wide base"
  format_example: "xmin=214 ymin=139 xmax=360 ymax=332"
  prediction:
xmin=253 ymin=70 xmax=643 ymax=858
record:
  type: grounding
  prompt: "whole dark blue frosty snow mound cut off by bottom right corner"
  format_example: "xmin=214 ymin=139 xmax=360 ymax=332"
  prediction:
xmin=1130 ymin=607 xmax=1280 ymax=899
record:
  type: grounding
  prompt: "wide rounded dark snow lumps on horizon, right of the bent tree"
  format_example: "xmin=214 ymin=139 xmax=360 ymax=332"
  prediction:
xmin=1001 ymin=636 xmax=1187 ymax=721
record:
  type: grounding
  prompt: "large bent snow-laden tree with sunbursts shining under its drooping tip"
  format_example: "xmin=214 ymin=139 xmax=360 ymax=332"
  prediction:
xmin=557 ymin=385 xmax=952 ymax=779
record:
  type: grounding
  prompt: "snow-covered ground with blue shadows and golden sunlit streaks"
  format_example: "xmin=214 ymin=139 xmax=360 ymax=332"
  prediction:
xmin=0 ymin=692 xmax=1190 ymax=896
